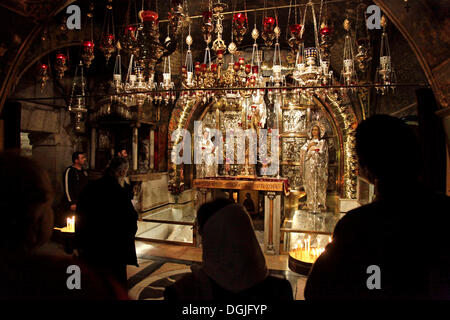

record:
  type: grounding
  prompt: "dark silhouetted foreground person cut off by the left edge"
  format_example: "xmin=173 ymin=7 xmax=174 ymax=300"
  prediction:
xmin=0 ymin=153 xmax=128 ymax=300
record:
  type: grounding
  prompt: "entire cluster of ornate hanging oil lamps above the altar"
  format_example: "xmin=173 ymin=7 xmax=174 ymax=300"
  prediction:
xmin=59 ymin=0 xmax=396 ymax=127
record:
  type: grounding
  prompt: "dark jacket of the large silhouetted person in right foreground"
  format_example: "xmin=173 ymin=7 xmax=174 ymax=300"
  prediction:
xmin=305 ymin=189 xmax=450 ymax=300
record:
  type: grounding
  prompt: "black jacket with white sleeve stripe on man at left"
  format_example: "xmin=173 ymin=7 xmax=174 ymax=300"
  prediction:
xmin=63 ymin=166 xmax=89 ymax=210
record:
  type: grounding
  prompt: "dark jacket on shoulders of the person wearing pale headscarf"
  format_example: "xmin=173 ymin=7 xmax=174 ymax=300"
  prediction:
xmin=164 ymin=267 xmax=293 ymax=301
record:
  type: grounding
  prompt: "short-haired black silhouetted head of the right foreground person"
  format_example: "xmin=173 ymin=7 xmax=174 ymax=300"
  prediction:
xmin=356 ymin=115 xmax=421 ymax=192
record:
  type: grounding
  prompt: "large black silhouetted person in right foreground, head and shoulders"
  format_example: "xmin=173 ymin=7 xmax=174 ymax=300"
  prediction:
xmin=305 ymin=115 xmax=450 ymax=299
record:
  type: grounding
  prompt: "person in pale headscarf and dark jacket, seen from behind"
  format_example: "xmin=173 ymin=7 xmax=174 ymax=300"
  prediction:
xmin=164 ymin=199 xmax=293 ymax=301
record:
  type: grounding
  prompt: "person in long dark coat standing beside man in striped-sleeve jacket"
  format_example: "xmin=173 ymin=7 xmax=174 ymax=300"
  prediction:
xmin=75 ymin=157 xmax=138 ymax=288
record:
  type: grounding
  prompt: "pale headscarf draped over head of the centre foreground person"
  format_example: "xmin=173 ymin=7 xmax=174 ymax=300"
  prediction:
xmin=202 ymin=204 xmax=268 ymax=292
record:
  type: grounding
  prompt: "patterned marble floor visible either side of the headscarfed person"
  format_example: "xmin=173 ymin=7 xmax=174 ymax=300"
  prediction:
xmin=127 ymin=241 xmax=306 ymax=300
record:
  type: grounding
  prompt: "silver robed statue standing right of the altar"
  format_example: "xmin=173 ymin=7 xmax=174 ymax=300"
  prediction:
xmin=300 ymin=121 xmax=328 ymax=212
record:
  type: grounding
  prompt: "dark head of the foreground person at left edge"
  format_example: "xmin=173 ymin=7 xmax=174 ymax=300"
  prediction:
xmin=0 ymin=153 xmax=53 ymax=256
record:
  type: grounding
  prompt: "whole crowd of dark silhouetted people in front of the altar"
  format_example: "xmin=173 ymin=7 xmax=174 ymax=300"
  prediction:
xmin=0 ymin=115 xmax=450 ymax=301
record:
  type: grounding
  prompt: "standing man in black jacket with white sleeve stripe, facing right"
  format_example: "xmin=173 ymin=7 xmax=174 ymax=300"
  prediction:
xmin=58 ymin=152 xmax=88 ymax=223
